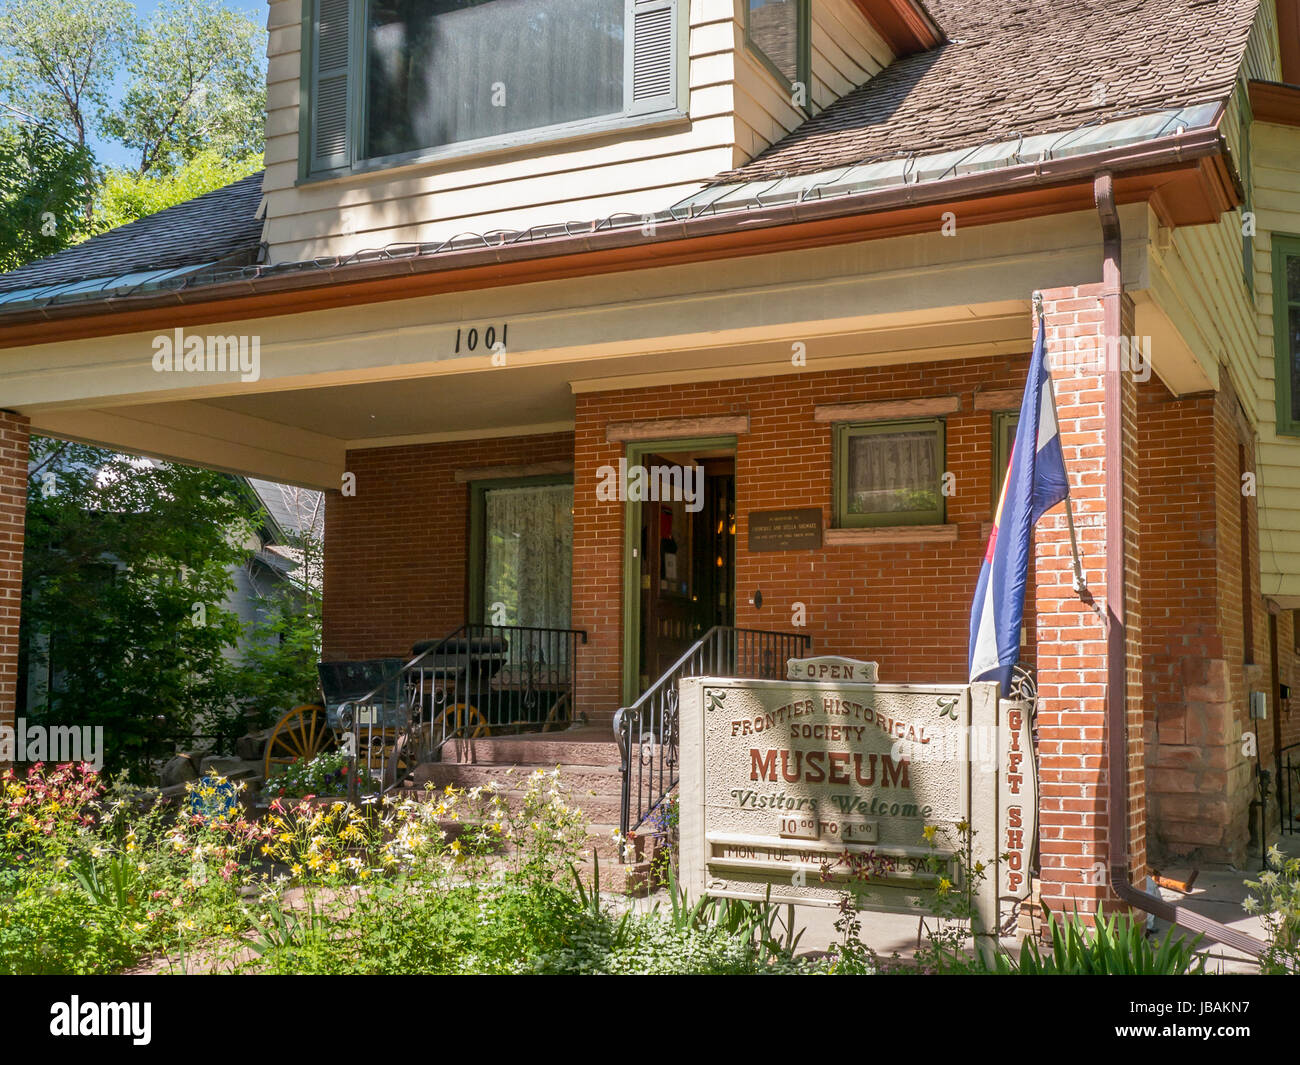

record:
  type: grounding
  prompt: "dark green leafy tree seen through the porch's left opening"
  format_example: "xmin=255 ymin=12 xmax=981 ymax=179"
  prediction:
xmin=21 ymin=437 xmax=260 ymax=772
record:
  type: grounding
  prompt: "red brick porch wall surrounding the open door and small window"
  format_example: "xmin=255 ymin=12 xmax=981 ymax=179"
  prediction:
xmin=573 ymin=356 xmax=1032 ymax=728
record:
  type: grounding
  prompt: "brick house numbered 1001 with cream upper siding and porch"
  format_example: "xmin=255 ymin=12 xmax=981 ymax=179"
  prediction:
xmin=0 ymin=0 xmax=1300 ymax=931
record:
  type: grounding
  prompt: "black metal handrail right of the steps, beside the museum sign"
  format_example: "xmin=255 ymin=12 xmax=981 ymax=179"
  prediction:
xmin=614 ymin=625 xmax=813 ymax=837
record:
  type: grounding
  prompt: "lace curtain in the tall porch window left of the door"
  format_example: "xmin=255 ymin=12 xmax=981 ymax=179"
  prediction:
xmin=484 ymin=485 xmax=573 ymax=628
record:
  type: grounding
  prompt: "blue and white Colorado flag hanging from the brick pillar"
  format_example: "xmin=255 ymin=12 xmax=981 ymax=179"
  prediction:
xmin=970 ymin=316 xmax=1070 ymax=696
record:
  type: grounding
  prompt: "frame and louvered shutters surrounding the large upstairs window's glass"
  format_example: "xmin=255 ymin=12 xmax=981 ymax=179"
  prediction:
xmin=298 ymin=0 xmax=686 ymax=185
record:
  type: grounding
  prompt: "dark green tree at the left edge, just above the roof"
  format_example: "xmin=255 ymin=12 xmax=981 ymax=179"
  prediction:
xmin=0 ymin=125 xmax=90 ymax=270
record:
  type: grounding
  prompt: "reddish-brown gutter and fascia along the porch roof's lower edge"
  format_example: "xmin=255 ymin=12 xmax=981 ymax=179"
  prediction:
xmin=0 ymin=127 xmax=1242 ymax=347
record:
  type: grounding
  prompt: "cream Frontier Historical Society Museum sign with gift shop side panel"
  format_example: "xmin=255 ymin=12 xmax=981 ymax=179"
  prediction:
xmin=680 ymin=681 xmax=1036 ymax=946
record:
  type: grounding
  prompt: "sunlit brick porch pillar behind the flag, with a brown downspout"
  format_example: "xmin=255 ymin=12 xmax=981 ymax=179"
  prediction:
xmin=1035 ymin=285 xmax=1145 ymax=914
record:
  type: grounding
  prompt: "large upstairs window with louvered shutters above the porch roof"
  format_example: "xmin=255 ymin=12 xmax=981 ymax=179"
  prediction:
xmin=304 ymin=0 xmax=688 ymax=176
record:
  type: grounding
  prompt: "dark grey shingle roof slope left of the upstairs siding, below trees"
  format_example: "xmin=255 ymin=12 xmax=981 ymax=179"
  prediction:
xmin=0 ymin=172 xmax=261 ymax=293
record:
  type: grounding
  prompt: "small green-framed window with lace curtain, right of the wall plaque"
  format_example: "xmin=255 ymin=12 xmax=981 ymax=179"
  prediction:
xmin=835 ymin=419 xmax=944 ymax=529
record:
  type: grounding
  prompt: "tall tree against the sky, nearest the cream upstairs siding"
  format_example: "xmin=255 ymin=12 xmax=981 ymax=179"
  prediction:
xmin=103 ymin=0 xmax=267 ymax=174
